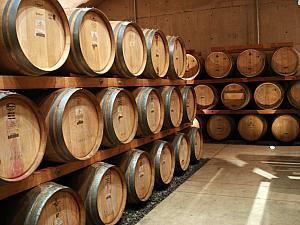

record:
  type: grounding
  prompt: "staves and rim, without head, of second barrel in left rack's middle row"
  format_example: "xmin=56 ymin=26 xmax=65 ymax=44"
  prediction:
xmin=40 ymin=88 xmax=103 ymax=162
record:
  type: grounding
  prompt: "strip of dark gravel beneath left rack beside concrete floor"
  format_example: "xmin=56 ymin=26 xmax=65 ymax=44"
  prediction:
xmin=117 ymin=159 xmax=208 ymax=225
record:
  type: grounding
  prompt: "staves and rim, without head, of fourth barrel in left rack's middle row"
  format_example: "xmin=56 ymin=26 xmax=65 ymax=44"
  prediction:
xmin=133 ymin=87 xmax=165 ymax=137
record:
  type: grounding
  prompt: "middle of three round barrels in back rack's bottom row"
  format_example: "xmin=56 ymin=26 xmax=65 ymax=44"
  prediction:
xmin=238 ymin=115 xmax=268 ymax=141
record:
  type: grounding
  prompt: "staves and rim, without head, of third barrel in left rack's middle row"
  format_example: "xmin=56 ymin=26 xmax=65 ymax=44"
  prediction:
xmin=96 ymin=88 xmax=138 ymax=147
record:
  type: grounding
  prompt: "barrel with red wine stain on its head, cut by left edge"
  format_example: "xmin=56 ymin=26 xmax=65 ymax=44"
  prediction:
xmin=0 ymin=91 xmax=47 ymax=182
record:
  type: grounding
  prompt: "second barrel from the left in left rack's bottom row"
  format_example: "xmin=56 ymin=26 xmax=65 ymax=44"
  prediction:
xmin=67 ymin=162 xmax=127 ymax=225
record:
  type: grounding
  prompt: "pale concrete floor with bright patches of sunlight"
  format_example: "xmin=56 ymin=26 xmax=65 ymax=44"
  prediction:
xmin=138 ymin=144 xmax=300 ymax=225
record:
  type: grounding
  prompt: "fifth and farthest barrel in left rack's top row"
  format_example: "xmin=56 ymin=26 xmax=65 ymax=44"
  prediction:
xmin=167 ymin=36 xmax=186 ymax=79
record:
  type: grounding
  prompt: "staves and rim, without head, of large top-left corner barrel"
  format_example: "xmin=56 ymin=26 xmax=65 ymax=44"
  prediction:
xmin=0 ymin=0 xmax=71 ymax=76
